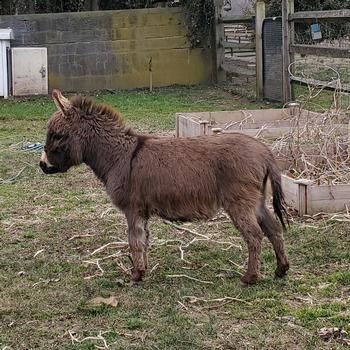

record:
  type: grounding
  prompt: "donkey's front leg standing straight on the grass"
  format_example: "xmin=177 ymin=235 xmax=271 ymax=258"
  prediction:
xmin=127 ymin=213 xmax=148 ymax=281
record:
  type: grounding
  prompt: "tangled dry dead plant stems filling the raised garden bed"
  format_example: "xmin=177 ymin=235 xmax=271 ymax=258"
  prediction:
xmin=272 ymin=61 xmax=350 ymax=184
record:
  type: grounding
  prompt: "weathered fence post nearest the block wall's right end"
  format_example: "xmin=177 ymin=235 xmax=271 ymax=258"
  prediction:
xmin=214 ymin=0 xmax=226 ymax=83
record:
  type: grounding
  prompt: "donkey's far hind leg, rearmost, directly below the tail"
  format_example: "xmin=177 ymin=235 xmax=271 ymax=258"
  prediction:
xmin=256 ymin=199 xmax=289 ymax=277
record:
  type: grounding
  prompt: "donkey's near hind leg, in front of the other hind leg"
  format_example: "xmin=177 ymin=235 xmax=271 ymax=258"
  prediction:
xmin=225 ymin=201 xmax=264 ymax=284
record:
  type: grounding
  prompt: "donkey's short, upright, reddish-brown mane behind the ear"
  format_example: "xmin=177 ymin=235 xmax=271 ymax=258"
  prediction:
xmin=71 ymin=95 xmax=126 ymax=128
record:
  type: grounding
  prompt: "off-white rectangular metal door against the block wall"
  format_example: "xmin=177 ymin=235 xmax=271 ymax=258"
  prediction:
xmin=12 ymin=47 xmax=48 ymax=96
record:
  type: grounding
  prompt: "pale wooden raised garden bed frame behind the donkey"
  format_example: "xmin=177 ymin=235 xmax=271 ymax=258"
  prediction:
xmin=176 ymin=109 xmax=350 ymax=215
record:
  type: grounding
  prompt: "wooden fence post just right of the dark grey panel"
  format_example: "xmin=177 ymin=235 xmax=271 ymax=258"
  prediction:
xmin=282 ymin=0 xmax=294 ymax=103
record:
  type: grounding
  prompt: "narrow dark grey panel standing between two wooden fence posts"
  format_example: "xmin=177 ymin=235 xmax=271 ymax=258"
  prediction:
xmin=263 ymin=17 xmax=283 ymax=101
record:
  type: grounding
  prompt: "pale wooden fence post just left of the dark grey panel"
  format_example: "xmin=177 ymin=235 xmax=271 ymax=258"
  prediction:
xmin=255 ymin=0 xmax=265 ymax=101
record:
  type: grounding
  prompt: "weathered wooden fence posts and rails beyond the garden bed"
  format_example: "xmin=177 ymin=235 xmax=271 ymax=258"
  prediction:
xmin=214 ymin=0 xmax=350 ymax=103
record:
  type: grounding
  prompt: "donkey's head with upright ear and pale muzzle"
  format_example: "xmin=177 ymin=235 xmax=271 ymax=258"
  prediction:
xmin=40 ymin=90 xmax=83 ymax=174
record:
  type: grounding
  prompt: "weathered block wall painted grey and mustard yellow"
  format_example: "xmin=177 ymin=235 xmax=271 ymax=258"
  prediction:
xmin=0 ymin=8 xmax=212 ymax=91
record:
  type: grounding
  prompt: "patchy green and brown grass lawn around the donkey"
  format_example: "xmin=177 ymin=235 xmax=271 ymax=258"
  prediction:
xmin=0 ymin=88 xmax=350 ymax=350
